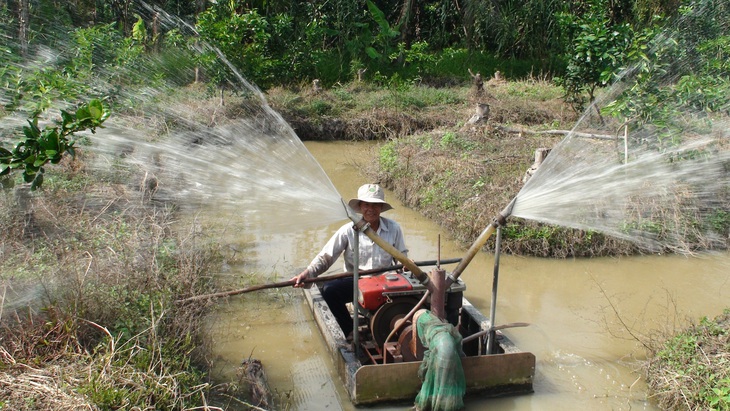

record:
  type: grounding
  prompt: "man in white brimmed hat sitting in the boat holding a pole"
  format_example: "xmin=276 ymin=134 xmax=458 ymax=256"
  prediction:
xmin=292 ymin=184 xmax=408 ymax=339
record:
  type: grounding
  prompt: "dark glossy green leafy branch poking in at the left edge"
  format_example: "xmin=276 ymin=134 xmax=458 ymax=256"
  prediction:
xmin=0 ymin=100 xmax=110 ymax=190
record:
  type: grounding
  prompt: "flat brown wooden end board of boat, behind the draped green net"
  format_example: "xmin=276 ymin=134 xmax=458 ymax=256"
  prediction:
xmin=353 ymin=352 xmax=535 ymax=404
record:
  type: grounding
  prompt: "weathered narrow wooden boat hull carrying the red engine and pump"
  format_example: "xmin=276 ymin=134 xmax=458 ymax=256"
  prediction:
xmin=304 ymin=278 xmax=535 ymax=405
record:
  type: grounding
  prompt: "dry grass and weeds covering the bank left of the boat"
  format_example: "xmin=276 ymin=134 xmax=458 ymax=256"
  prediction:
xmin=0 ymin=145 xmax=222 ymax=410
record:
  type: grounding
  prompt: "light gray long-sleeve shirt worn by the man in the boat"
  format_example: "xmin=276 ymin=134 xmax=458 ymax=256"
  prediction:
xmin=307 ymin=217 xmax=408 ymax=277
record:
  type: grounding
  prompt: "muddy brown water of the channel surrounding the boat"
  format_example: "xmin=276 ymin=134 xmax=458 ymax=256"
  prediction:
xmin=210 ymin=142 xmax=730 ymax=410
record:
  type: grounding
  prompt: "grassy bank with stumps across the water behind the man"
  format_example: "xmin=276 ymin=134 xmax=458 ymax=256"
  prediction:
xmin=269 ymin=79 xmax=637 ymax=258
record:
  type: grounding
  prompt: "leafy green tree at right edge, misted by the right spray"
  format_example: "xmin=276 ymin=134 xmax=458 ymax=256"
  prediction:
xmin=603 ymin=6 xmax=730 ymax=154
